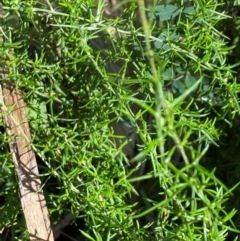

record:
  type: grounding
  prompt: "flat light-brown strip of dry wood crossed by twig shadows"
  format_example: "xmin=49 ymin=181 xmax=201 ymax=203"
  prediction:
xmin=0 ymin=5 xmax=54 ymax=241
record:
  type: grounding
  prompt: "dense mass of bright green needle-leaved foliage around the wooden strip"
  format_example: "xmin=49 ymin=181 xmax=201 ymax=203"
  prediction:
xmin=0 ymin=0 xmax=240 ymax=241
